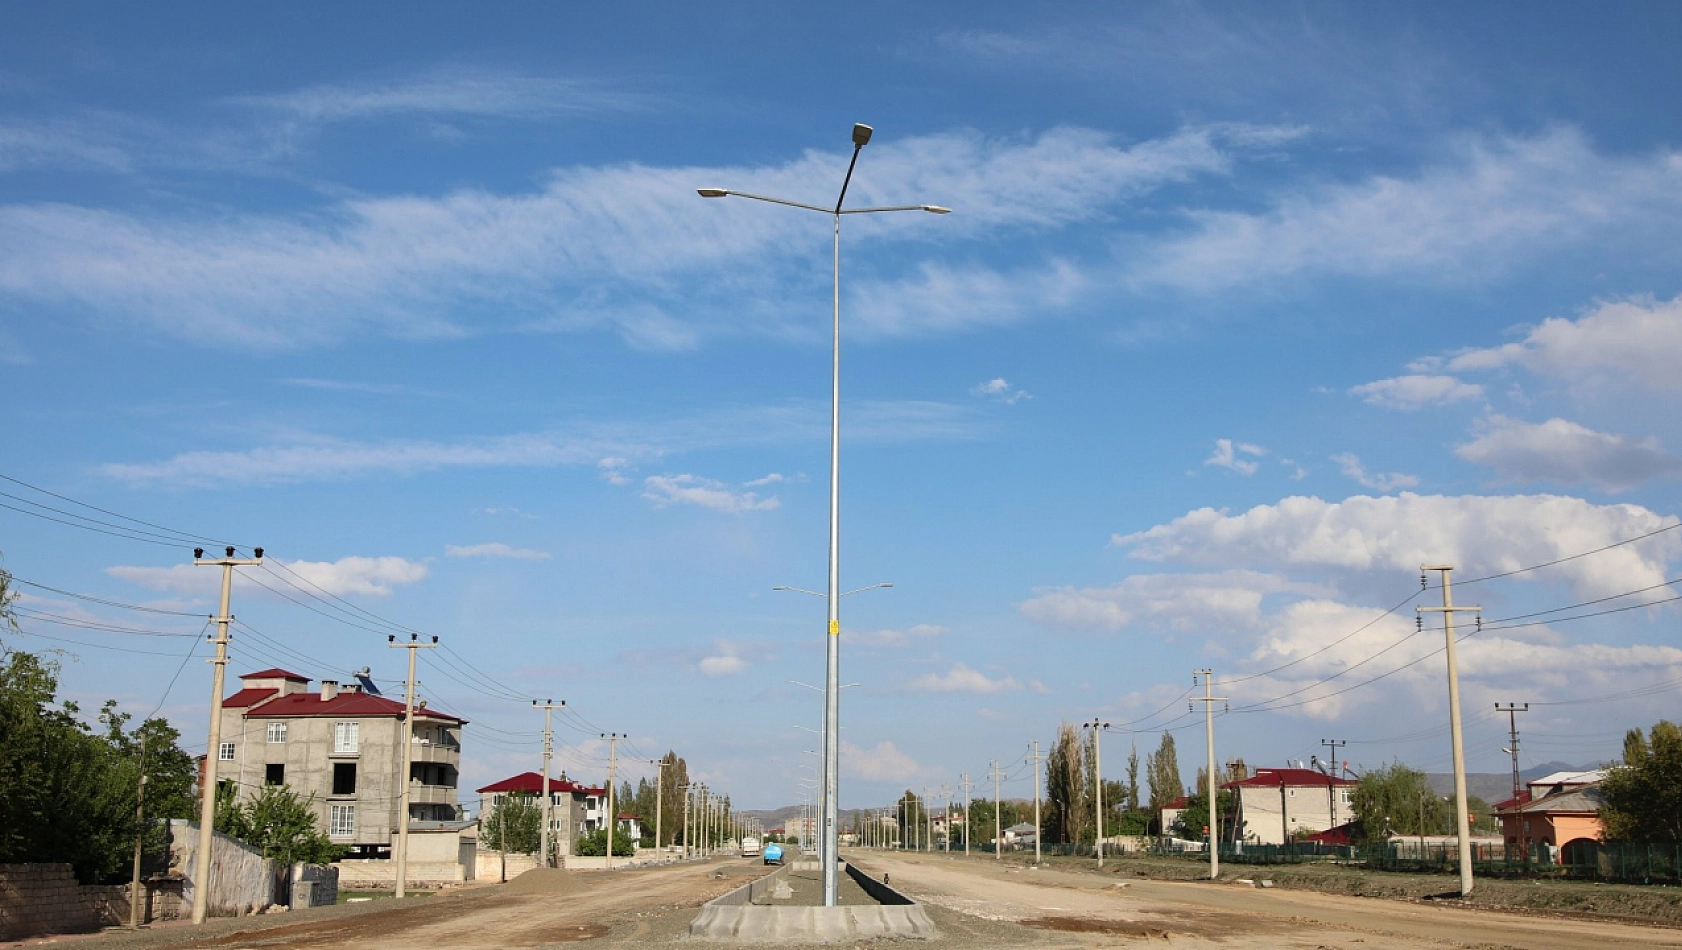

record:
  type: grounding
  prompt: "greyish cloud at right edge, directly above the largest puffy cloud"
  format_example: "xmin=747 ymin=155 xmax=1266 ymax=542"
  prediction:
xmin=1455 ymin=415 xmax=1682 ymax=491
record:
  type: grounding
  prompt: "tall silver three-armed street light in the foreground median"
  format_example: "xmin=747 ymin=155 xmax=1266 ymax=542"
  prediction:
xmin=698 ymin=124 xmax=950 ymax=906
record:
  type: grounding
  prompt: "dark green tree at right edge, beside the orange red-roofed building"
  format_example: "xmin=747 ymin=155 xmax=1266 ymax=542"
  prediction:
xmin=1600 ymin=720 xmax=1682 ymax=844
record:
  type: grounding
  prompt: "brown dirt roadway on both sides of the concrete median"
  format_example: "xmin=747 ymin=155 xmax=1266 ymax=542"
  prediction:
xmin=19 ymin=852 xmax=1682 ymax=950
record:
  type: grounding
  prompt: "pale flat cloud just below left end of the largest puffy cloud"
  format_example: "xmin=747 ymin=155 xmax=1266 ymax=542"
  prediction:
xmin=1016 ymin=570 xmax=1315 ymax=632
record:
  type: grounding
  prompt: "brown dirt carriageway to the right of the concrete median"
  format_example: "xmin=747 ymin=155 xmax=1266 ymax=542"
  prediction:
xmin=854 ymin=852 xmax=1682 ymax=950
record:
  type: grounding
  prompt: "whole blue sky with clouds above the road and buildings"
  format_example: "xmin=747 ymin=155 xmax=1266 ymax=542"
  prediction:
xmin=0 ymin=3 xmax=1682 ymax=807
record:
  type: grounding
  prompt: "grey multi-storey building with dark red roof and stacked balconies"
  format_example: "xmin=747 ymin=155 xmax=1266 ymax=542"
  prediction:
xmin=212 ymin=669 xmax=466 ymax=858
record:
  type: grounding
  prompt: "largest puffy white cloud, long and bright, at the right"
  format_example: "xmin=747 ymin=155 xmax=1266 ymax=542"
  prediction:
xmin=1112 ymin=491 xmax=1682 ymax=597
